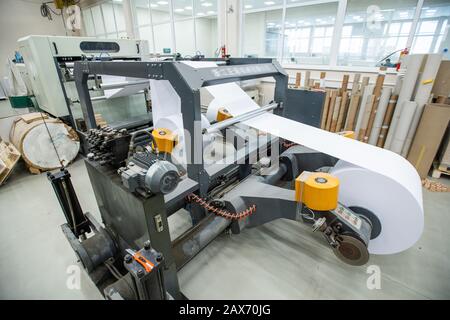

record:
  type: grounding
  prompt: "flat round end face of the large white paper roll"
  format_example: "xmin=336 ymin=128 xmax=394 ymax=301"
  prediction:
xmin=330 ymin=161 xmax=423 ymax=254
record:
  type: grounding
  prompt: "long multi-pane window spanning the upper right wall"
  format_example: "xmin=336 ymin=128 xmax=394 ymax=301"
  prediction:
xmin=241 ymin=0 xmax=450 ymax=67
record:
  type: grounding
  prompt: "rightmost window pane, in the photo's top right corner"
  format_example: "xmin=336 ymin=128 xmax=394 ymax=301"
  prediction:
xmin=411 ymin=0 xmax=450 ymax=53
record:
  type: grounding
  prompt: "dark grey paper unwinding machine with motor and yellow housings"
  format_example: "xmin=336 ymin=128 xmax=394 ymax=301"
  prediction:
xmin=49 ymin=58 xmax=381 ymax=299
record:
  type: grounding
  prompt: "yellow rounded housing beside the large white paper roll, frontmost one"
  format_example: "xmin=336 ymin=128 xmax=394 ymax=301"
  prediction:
xmin=295 ymin=171 xmax=339 ymax=211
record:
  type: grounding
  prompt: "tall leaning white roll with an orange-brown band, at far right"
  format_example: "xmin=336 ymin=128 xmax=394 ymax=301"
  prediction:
xmin=402 ymin=54 xmax=442 ymax=157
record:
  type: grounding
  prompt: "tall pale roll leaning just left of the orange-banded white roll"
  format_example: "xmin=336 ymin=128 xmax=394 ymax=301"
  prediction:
xmin=384 ymin=54 xmax=425 ymax=150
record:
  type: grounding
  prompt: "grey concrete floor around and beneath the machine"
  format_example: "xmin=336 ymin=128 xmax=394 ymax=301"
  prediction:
xmin=0 ymin=160 xmax=450 ymax=299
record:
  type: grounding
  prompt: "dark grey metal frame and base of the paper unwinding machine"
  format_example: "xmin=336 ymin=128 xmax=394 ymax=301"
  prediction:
xmin=67 ymin=59 xmax=372 ymax=299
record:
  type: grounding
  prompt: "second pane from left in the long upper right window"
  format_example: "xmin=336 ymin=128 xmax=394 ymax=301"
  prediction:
xmin=283 ymin=2 xmax=338 ymax=65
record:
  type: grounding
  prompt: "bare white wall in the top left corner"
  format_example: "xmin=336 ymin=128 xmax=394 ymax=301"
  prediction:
xmin=0 ymin=0 xmax=65 ymax=78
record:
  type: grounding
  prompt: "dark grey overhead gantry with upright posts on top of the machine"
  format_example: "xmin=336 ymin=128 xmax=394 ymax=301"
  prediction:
xmin=74 ymin=58 xmax=288 ymax=208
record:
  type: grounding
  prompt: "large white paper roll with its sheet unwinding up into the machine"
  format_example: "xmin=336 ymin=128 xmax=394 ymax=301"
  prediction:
xmin=206 ymin=87 xmax=423 ymax=254
